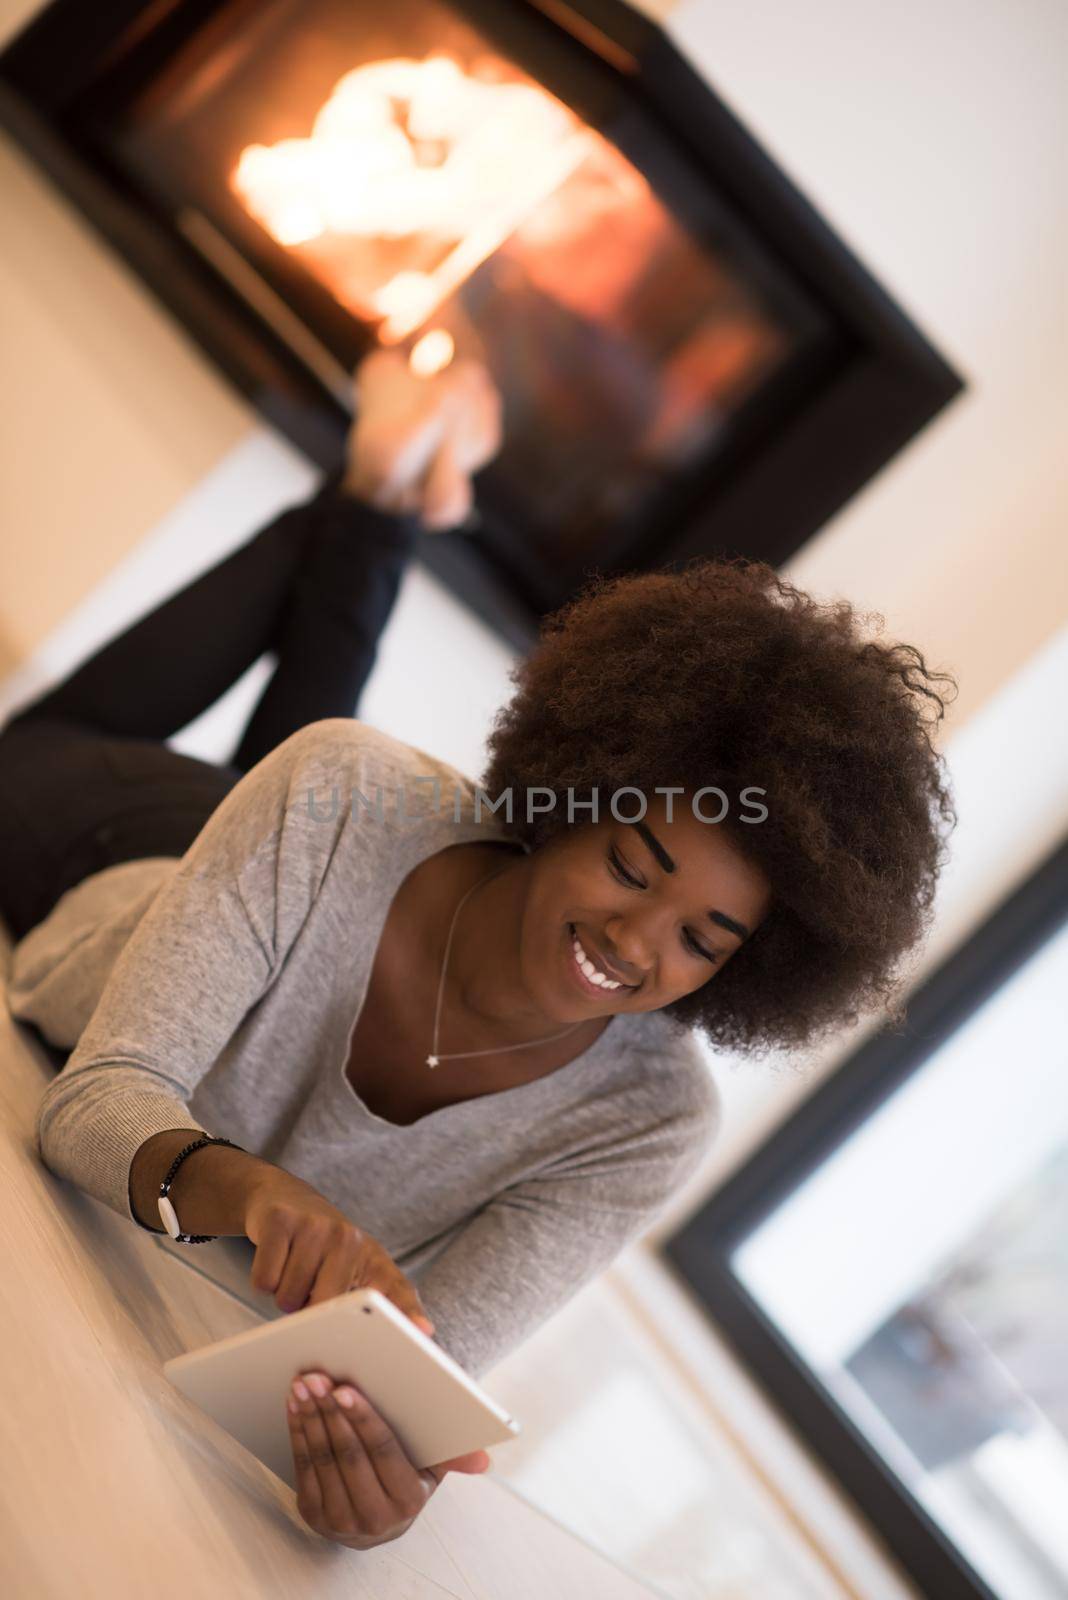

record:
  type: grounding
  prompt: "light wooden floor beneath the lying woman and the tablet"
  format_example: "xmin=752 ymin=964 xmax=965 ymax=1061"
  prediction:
xmin=0 ymin=928 xmax=654 ymax=1600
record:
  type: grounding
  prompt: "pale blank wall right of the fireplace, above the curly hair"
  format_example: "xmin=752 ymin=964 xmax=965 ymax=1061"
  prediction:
xmin=670 ymin=0 xmax=1068 ymax=726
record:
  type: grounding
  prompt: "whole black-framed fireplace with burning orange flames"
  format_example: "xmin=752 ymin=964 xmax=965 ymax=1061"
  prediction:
xmin=0 ymin=0 xmax=962 ymax=648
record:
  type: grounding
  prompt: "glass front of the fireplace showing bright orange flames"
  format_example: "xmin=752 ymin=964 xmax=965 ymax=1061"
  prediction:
xmin=94 ymin=0 xmax=830 ymax=610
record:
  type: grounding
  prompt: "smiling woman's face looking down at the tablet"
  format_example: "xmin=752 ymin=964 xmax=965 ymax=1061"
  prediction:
xmin=523 ymin=795 xmax=771 ymax=1018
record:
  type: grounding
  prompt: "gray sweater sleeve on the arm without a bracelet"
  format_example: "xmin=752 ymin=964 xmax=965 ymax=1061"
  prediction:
xmin=411 ymin=1074 xmax=719 ymax=1378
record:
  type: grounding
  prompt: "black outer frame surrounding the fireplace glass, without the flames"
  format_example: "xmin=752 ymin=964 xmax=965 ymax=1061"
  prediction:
xmin=0 ymin=0 xmax=966 ymax=651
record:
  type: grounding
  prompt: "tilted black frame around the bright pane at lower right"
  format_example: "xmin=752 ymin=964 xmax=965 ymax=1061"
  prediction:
xmin=660 ymin=837 xmax=1068 ymax=1600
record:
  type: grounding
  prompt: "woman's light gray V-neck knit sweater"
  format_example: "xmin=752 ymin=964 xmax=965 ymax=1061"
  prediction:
xmin=8 ymin=717 xmax=719 ymax=1378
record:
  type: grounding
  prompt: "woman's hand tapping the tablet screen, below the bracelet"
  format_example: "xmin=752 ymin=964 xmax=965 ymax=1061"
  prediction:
xmin=245 ymin=1166 xmax=433 ymax=1334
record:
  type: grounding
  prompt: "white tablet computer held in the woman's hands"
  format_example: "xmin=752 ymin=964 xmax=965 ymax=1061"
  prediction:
xmin=163 ymin=1290 xmax=520 ymax=1490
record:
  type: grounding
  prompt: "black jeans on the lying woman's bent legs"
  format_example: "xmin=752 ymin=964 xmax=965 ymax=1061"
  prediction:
xmin=0 ymin=474 xmax=419 ymax=939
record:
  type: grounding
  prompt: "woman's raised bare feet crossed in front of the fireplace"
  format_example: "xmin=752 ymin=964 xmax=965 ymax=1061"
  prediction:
xmin=344 ymin=350 xmax=502 ymax=531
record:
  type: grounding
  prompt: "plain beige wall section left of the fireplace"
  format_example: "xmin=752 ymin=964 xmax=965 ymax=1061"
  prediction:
xmin=0 ymin=0 xmax=253 ymax=677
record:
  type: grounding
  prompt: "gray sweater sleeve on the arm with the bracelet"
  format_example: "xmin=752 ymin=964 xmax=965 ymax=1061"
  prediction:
xmin=37 ymin=725 xmax=342 ymax=1226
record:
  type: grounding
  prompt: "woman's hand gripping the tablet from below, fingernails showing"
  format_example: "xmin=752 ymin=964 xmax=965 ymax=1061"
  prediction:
xmin=286 ymin=1373 xmax=489 ymax=1550
